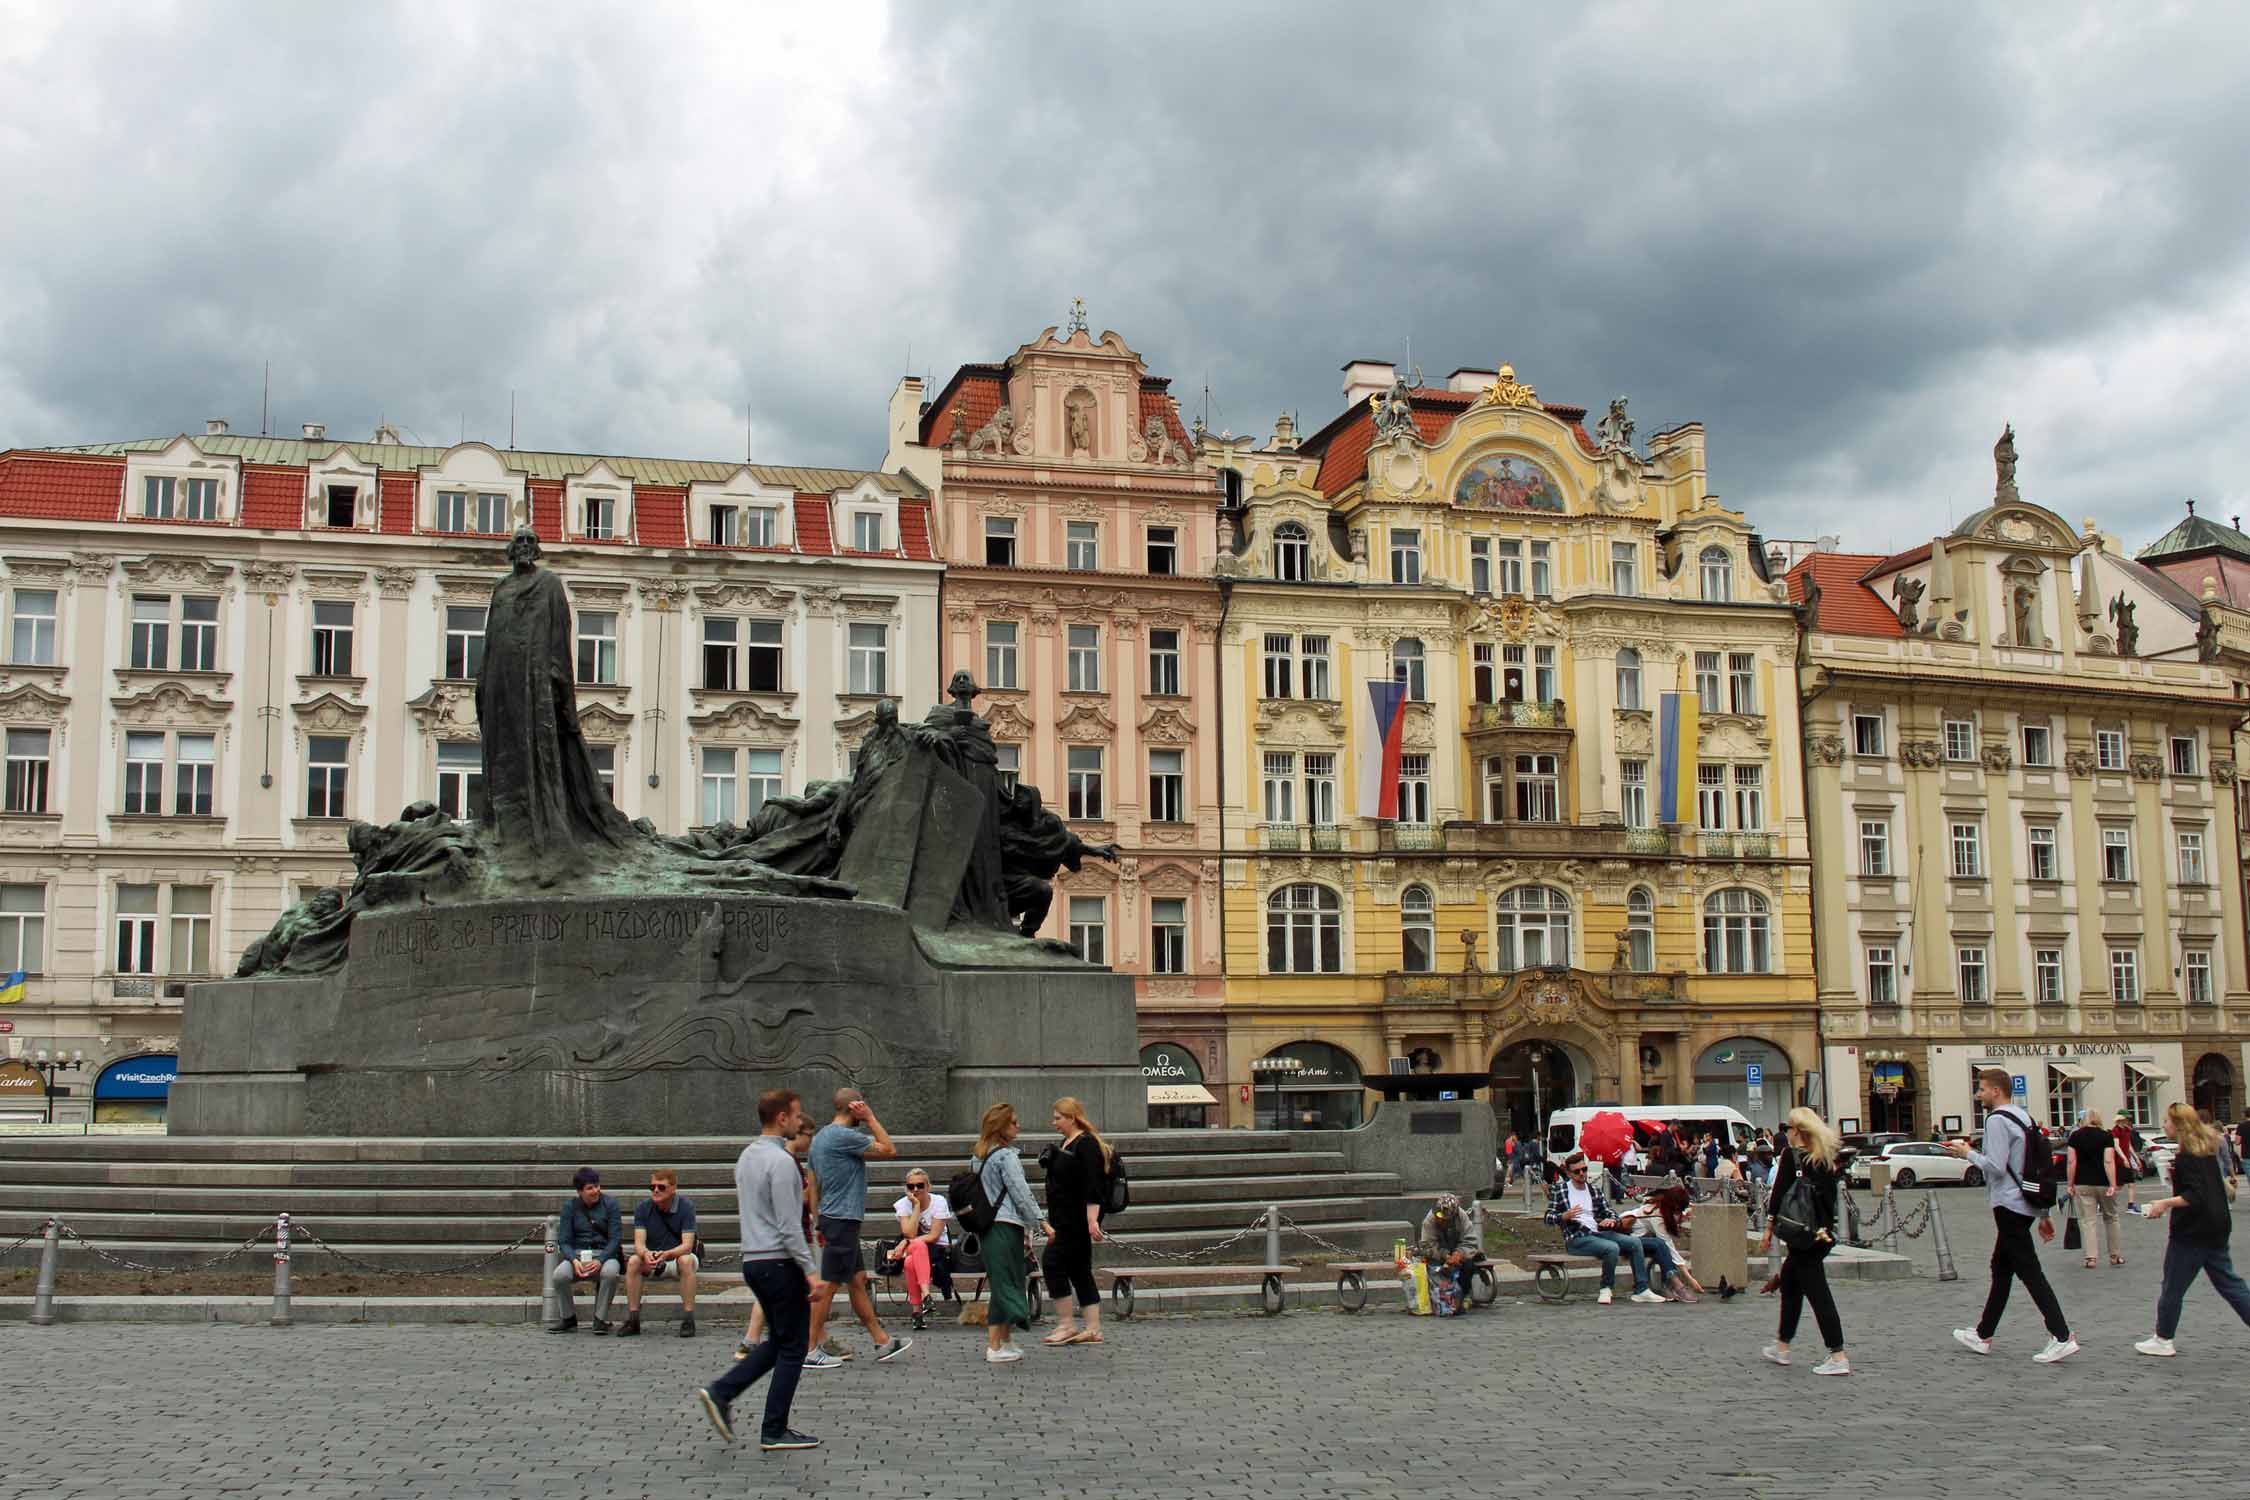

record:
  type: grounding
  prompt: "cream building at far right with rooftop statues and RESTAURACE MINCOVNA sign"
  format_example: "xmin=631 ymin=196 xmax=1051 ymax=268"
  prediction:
xmin=1789 ymin=434 xmax=2250 ymax=1136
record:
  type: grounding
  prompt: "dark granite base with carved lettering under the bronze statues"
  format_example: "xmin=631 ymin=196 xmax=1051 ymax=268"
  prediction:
xmin=169 ymin=895 xmax=1148 ymax=1136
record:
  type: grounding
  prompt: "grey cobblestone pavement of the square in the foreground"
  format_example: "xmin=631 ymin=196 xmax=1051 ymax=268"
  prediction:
xmin=0 ymin=1192 xmax=2250 ymax=1500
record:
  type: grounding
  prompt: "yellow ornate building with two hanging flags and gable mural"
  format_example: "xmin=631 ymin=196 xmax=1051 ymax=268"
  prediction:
xmin=1204 ymin=362 xmax=1818 ymax=1129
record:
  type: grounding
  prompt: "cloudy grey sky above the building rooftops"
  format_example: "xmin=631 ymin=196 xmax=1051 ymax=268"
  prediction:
xmin=0 ymin=0 xmax=2250 ymax=549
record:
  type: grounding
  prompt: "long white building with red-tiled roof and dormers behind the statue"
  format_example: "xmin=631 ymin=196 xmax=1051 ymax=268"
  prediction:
xmin=0 ymin=423 xmax=943 ymax=1101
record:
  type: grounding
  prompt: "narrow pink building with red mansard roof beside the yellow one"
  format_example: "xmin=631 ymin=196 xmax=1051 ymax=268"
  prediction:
xmin=887 ymin=315 xmax=1224 ymax=1124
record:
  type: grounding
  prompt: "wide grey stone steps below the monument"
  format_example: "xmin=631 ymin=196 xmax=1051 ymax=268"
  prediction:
xmin=0 ymin=1131 xmax=1429 ymax=1293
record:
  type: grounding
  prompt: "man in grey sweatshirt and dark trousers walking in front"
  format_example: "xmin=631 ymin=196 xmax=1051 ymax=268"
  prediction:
xmin=695 ymin=1088 xmax=821 ymax=1453
